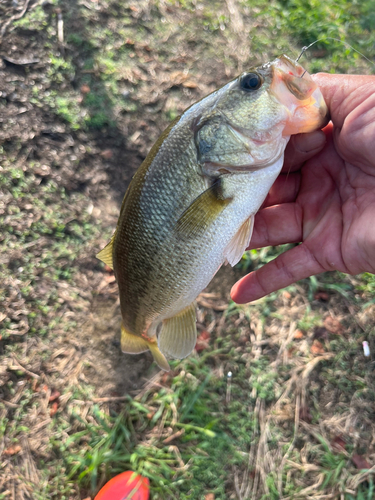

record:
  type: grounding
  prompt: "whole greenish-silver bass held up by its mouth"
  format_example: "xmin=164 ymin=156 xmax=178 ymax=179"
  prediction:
xmin=97 ymin=55 xmax=328 ymax=371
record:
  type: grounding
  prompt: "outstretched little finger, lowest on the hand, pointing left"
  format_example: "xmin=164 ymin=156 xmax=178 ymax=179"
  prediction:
xmin=231 ymin=243 xmax=324 ymax=304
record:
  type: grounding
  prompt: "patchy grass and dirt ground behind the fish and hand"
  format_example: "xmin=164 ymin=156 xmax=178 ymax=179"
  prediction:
xmin=0 ymin=0 xmax=375 ymax=500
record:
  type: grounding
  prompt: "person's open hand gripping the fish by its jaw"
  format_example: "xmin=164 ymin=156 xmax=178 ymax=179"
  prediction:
xmin=231 ymin=73 xmax=375 ymax=303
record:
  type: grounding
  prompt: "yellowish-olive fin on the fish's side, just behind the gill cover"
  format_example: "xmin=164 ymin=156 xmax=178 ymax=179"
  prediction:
xmin=176 ymin=179 xmax=231 ymax=238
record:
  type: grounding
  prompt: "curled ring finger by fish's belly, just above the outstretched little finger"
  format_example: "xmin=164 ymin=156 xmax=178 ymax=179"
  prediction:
xmin=249 ymin=203 xmax=302 ymax=248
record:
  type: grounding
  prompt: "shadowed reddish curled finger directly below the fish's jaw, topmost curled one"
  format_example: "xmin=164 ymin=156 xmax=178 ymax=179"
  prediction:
xmin=283 ymin=130 xmax=326 ymax=172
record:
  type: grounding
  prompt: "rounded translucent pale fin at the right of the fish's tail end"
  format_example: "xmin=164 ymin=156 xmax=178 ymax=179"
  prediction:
xmin=158 ymin=304 xmax=197 ymax=359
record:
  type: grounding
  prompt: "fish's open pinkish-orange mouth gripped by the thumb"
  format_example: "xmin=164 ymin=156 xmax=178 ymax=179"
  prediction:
xmin=270 ymin=55 xmax=329 ymax=136
